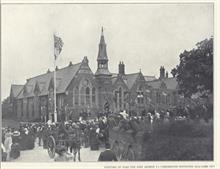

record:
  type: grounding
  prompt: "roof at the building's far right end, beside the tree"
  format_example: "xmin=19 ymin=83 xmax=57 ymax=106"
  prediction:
xmin=147 ymin=77 xmax=178 ymax=90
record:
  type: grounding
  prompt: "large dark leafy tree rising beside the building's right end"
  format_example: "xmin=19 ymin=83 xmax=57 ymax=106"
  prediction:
xmin=176 ymin=37 xmax=213 ymax=97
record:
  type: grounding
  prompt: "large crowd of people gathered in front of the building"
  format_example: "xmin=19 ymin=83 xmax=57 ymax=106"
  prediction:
xmin=1 ymin=102 xmax=210 ymax=161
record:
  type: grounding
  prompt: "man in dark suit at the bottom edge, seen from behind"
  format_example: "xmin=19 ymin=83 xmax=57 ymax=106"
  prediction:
xmin=98 ymin=143 xmax=117 ymax=161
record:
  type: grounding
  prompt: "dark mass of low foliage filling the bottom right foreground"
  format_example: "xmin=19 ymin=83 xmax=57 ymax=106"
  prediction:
xmin=143 ymin=121 xmax=213 ymax=161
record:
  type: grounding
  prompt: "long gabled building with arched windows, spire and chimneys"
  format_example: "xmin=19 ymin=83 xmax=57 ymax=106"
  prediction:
xmin=7 ymin=31 xmax=178 ymax=121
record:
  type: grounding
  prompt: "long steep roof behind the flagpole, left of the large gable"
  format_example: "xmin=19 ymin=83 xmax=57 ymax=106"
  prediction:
xmin=19 ymin=62 xmax=81 ymax=98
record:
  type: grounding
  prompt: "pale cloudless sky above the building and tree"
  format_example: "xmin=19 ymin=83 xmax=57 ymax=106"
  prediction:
xmin=1 ymin=3 xmax=214 ymax=100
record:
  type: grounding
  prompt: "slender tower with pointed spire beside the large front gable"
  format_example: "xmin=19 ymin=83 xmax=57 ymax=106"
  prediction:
xmin=95 ymin=27 xmax=113 ymax=112
